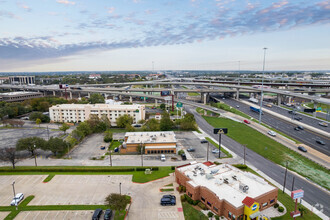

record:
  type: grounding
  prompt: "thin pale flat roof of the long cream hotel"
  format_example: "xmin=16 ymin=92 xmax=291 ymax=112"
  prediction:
xmin=51 ymin=104 xmax=143 ymax=110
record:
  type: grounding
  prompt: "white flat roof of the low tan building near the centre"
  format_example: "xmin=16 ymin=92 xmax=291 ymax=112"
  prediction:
xmin=125 ymin=131 xmax=176 ymax=144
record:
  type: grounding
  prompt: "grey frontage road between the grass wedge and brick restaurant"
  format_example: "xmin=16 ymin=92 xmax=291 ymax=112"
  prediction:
xmin=185 ymin=106 xmax=330 ymax=216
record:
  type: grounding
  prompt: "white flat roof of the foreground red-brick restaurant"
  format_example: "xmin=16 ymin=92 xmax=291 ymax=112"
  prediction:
xmin=177 ymin=162 xmax=276 ymax=208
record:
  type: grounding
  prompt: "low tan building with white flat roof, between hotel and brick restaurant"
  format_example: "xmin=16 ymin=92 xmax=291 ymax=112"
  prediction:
xmin=120 ymin=131 xmax=177 ymax=154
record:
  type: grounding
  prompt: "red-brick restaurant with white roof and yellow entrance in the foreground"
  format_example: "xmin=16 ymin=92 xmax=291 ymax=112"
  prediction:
xmin=175 ymin=162 xmax=278 ymax=220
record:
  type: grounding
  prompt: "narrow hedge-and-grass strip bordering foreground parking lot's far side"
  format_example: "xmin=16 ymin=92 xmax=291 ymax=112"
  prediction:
xmin=0 ymin=166 xmax=174 ymax=183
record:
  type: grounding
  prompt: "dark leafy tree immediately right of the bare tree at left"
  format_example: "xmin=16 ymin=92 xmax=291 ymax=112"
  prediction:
xmin=16 ymin=137 xmax=47 ymax=156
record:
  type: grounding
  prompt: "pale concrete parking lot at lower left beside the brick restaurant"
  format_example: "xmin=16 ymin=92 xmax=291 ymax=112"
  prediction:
xmin=0 ymin=174 xmax=184 ymax=220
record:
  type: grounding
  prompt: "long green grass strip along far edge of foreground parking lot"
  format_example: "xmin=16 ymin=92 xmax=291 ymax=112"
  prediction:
xmin=0 ymin=166 xmax=174 ymax=183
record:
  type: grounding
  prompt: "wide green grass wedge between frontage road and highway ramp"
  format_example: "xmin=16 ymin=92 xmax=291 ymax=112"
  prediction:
xmin=203 ymin=116 xmax=330 ymax=190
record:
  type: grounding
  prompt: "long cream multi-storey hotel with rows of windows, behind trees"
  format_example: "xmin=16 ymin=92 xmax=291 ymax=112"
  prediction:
xmin=49 ymin=104 xmax=145 ymax=125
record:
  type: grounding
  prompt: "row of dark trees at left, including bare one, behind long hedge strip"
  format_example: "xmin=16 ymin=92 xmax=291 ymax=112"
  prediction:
xmin=0 ymin=137 xmax=68 ymax=169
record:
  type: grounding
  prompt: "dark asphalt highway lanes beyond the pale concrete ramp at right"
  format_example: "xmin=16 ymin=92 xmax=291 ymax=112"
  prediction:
xmin=217 ymin=99 xmax=330 ymax=156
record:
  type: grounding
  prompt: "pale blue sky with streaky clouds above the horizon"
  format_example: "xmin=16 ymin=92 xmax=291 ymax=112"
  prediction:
xmin=0 ymin=0 xmax=330 ymax=72
